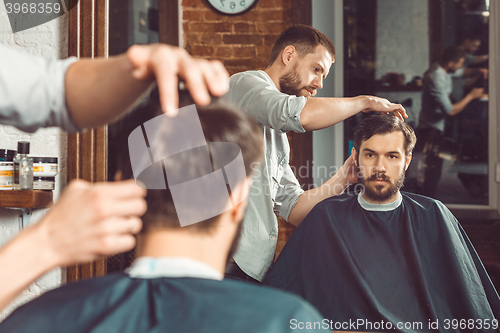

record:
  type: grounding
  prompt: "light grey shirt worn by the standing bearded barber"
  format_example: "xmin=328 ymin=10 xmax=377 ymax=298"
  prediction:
xmin=225 ymin=71 xmax=307 ymax=281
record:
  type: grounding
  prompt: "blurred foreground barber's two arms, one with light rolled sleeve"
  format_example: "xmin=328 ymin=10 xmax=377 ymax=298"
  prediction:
xmin=0 ymin=44 xmax=228 ymax=309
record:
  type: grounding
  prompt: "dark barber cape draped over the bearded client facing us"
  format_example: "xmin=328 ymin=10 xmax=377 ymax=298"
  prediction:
xmin=264 ymin=192 xmax=500 ymax=332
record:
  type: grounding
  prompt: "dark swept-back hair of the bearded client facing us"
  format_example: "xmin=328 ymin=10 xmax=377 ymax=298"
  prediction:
xmin=354 ymin=113 xmax=417 ymax=156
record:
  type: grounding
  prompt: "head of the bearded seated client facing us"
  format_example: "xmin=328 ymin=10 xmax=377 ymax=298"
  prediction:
xmin=352 ymin=114 xmax=417 ymax=204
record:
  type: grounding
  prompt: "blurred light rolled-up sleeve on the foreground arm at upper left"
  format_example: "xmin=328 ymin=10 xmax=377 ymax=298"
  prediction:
xmin=0 ymin=45 xmax=79 ymax=132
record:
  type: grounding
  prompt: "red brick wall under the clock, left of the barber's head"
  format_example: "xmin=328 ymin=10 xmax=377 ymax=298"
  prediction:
xmin=182 ymin=0 xmax=292 ymax=74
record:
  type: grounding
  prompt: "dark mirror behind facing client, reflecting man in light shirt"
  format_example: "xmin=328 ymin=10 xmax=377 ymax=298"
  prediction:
xmin=344 ymin=0 xmax=489 ymax=205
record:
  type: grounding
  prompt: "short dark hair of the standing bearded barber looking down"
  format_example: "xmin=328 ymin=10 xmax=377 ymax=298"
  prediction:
xmin=267 ymin=24 xmax=335 ymax=67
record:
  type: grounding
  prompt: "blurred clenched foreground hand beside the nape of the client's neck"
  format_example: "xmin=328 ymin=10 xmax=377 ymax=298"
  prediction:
xmin=34 ymin=180 xmax=146 ymax=266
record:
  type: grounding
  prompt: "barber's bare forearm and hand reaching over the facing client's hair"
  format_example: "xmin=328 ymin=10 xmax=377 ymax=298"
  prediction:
xmin=300 ymin=96 xmax=407 ymax=131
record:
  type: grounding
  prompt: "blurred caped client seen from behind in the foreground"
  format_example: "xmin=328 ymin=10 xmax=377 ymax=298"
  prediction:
xmin=0 ymin=89 xmax=322 ymax=333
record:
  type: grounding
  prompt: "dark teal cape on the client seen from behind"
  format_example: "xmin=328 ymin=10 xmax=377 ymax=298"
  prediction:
xmin=0 ymin=274 xmax=323 ymax=333
